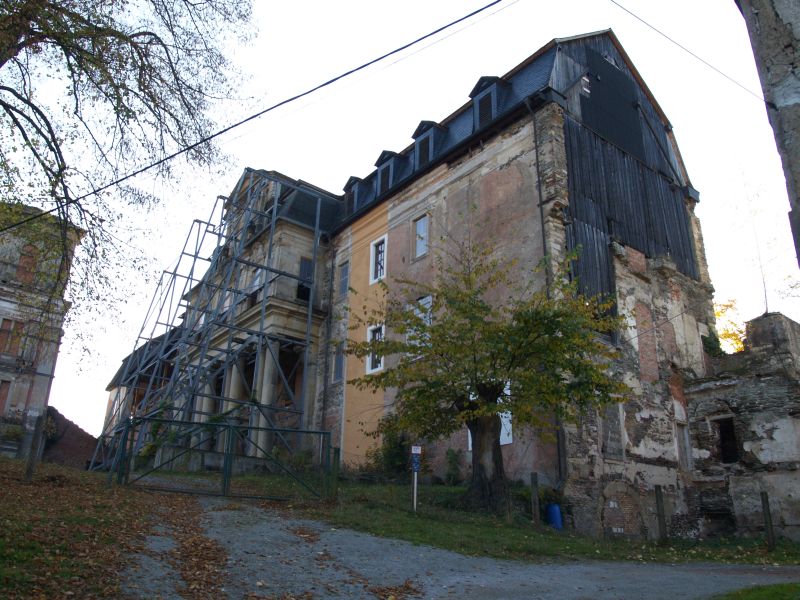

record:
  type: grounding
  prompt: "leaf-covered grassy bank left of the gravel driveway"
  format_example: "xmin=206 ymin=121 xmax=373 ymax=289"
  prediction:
xmin=0 ymin=459 xmax=158 ymax=600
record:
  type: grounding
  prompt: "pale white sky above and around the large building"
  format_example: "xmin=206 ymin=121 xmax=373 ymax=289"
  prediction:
xmin=50 ymin=0 xmax=800 ymax=435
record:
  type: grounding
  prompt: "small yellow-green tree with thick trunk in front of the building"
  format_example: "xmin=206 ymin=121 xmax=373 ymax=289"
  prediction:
xmin=348 ymin=241 xmax=626 ymax=511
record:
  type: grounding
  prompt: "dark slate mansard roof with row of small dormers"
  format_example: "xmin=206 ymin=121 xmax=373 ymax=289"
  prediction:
xmin=230 ymin=29 xmax=690 ymax=232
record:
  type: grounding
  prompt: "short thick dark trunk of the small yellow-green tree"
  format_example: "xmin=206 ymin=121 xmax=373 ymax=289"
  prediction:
xmin=467 ymin=415 xmax=508 ymax=513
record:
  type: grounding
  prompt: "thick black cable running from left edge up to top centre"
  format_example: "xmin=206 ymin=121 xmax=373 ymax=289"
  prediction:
xmin=0 ymin=0 xmax=504 ymax=239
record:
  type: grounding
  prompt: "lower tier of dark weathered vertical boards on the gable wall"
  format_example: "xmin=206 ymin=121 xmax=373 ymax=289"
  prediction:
xmin=564 ymin=116 xmax=697 ymax=293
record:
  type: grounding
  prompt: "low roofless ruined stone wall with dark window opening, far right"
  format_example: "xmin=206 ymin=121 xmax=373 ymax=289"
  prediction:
xmin=686 ymin=313 xmax=800 ymax=539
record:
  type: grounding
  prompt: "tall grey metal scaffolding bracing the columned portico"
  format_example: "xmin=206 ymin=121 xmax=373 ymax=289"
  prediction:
xmin=92 ymin=169 xmax=339 ymax=496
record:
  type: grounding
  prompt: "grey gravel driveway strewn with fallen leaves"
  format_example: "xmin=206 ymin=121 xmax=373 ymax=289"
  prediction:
xmin=123 ymin=498 xmax=800 ymax=600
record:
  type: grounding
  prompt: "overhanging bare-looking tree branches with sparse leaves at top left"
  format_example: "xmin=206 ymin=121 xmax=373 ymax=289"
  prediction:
xmin=0 ymin=0 xmax=250 ymax=332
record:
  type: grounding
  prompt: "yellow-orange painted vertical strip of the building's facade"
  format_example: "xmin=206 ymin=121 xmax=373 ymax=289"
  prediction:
xmin=342 ymin=202 xmax=391 ymax=465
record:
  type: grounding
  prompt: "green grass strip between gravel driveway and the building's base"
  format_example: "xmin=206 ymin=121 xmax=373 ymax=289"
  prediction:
xmin=303 ymin=482 xmax=800 ymax=564
